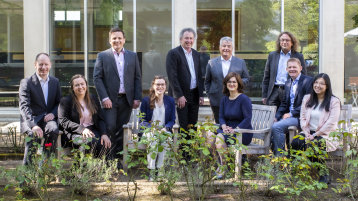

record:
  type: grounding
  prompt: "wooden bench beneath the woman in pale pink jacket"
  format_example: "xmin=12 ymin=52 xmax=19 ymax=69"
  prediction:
xmin=288 ymin=104 xmax=352 ymax=167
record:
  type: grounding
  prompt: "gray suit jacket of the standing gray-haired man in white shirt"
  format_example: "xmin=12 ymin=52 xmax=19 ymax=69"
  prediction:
xmin=205 ymin=56 xmax=250 ymax=106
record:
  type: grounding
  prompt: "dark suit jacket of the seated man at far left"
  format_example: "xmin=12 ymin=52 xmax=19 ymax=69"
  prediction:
xmin=19 ymin=74 xmax=61 ymax=133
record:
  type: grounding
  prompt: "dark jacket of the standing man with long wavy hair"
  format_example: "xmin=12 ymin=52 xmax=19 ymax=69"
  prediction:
xmin=262 ymin=51 xmax=307 ymax=102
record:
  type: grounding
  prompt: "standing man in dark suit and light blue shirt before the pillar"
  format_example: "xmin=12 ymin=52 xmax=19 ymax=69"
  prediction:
xmin=166 ymin=28 xmax=204 ymax=132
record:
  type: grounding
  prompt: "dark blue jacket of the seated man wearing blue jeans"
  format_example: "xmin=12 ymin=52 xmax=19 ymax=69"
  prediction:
xmin=276 ymin=74 xmax=313 ymax=121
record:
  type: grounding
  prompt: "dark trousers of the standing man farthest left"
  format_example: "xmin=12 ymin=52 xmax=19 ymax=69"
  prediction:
xmin=104 ymin=95 xmax=132 ymax=158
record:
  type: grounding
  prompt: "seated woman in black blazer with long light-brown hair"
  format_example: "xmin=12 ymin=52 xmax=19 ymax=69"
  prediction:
xmin=58 ymin=74 xmax=111 ymax=156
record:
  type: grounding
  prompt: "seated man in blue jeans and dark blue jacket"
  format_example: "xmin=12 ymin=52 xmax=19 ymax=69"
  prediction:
xmin=271 ymin=58 xmax=312 ymax=156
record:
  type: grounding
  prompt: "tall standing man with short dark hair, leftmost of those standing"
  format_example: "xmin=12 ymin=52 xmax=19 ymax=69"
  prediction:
xmin=93 ymin=28 xmax=142 ymax=158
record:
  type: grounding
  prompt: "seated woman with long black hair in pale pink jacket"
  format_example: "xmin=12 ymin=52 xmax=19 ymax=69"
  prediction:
xmin=291 ymin=73 xmax=341 ymax=183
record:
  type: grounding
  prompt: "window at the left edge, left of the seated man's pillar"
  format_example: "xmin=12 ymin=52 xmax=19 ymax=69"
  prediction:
xmin=0 ymin=0 xmax=24 ymax=107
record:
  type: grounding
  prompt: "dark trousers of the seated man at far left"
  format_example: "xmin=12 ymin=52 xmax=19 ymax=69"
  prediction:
xmin=23 ymin=119 xmax=59 ymax=165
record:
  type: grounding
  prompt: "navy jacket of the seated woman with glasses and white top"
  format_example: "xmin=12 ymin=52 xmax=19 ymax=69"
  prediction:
xmin=140 ymin=95 xmax=175 ymax=131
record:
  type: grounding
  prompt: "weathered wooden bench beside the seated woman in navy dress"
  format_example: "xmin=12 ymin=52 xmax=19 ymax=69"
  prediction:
xmin=235 ymin=104 xmax=276 ymax=178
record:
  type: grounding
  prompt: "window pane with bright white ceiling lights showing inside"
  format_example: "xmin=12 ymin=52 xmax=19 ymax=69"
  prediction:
xmin=50 ymin=0 xmax=84 ymax=94
